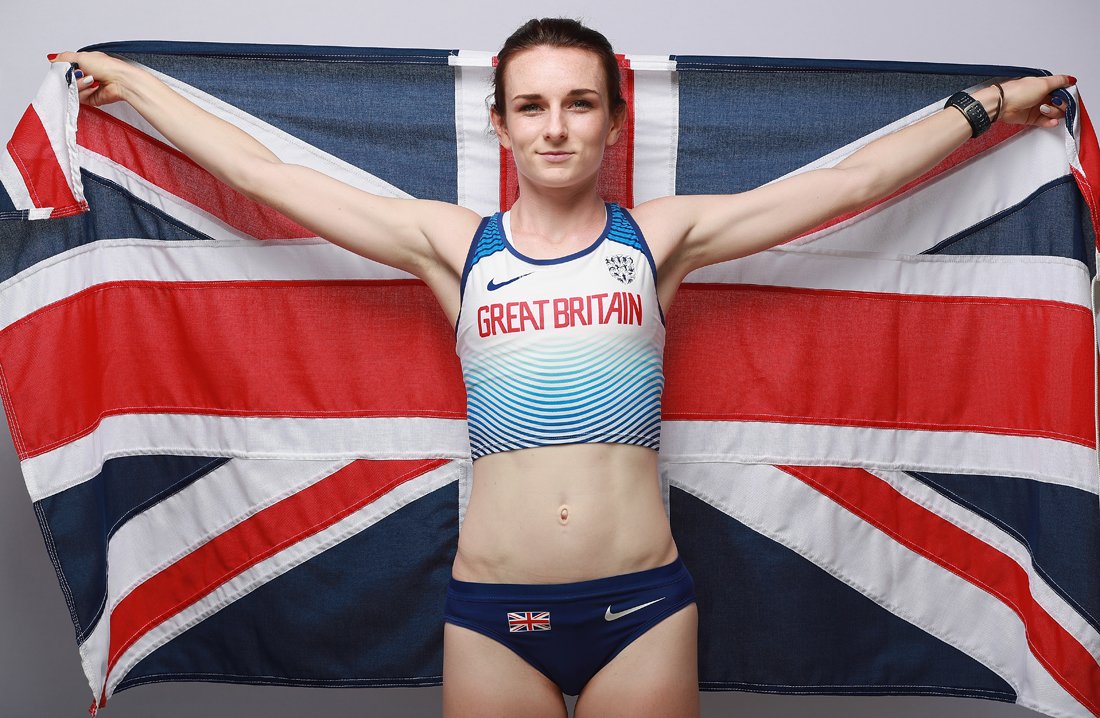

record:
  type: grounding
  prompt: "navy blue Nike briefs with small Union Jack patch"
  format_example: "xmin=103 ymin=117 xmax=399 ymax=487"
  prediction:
xmin=444 ymin=556 xmax=695 ymax=696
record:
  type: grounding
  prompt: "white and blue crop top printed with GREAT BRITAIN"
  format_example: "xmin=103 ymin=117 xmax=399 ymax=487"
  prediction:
xmin=455 ymin=203 xmax=664 ymax=459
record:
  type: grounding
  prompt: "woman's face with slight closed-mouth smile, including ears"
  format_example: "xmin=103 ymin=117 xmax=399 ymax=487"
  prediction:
xmin=492 ymin=47 xmax=624 ymax=193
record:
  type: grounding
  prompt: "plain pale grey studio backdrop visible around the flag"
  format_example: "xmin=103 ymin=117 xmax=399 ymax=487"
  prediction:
xmin=0 ymin=0 xmax=1100 ymax=718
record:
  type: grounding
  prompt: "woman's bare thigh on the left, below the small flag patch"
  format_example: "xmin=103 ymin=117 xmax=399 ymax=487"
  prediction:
xmin=443 ymin=623 xmax=567 ymax=718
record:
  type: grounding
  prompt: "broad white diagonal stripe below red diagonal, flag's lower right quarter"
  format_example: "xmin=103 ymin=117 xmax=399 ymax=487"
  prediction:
xmin=670 ymin=464 xmax=1091 ymax=718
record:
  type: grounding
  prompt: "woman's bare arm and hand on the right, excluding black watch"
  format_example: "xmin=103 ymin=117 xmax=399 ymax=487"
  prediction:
xmin=635 ymin=75 xmax=1076 ymax=278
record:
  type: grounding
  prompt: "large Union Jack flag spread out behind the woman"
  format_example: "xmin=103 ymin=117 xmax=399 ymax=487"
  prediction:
xmin=0 ymin=42 xmax=1100 ymax=716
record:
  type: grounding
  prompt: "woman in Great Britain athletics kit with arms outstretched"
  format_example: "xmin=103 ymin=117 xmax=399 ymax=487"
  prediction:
xmin=51 ymin=20 xmax=1075 ymax=718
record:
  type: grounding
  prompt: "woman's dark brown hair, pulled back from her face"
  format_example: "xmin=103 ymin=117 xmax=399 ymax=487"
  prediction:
xmin=493 ymin=18 xmax=626 ymax=118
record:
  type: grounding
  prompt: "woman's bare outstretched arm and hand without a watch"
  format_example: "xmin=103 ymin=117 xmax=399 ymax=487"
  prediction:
xmin=52 ymin=52 xmax=480 ymax=284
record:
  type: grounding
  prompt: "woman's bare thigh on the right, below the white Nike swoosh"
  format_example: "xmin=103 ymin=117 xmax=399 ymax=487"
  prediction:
xmin=574 ymin=604 xmax=699 ymax=718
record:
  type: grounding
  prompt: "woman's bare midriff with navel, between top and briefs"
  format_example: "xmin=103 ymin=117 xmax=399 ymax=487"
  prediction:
xmin=452 ymin=444 xmax=677 ymax=584
